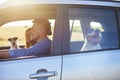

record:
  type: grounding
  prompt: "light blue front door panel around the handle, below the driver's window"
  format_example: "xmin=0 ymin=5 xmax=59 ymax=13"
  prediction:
xmin=0 ymin=56 xmax=61 ymax=80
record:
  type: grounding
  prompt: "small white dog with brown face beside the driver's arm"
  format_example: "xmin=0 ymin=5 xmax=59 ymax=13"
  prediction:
xmin=8 ymin=37 xmax=20 ymax=50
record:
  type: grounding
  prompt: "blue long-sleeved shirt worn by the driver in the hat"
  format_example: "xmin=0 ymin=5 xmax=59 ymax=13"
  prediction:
xmin=8 ymin=38 xmax=51 ymax=58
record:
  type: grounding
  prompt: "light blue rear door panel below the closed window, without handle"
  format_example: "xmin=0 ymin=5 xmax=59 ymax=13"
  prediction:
xmin=62 ymin=50 xmax=120 ymax=80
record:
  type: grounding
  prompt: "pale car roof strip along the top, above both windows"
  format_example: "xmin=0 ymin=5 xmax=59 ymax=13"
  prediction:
xmin=0 ymin=0 xmax=120 ymax=8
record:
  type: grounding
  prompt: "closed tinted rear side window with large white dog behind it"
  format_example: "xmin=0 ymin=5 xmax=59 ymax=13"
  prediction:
xmin=69 ymin=8 xmax=118 ymax=52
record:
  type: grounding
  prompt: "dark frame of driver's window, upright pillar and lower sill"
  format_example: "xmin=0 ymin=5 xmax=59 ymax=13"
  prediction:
xmin=0 ymin=4 xmax=63 ymax=61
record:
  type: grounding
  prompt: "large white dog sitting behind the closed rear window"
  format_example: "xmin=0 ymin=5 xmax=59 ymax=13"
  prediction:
xmin=81 ymin=29 xmax=102 ymax=51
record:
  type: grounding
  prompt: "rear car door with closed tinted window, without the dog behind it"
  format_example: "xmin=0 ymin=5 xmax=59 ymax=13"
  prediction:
xmin=62 ymin=5 xmax=120 ymax=80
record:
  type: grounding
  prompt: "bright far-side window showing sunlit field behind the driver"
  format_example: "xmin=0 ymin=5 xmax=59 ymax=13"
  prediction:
xmin=0 ymin=19 xmax=55 ymax=47
